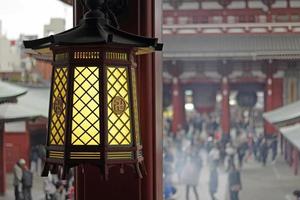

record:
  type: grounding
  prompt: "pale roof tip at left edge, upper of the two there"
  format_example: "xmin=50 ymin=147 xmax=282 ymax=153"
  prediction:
xmin=0 ymin=81 xmax=27 ymax=104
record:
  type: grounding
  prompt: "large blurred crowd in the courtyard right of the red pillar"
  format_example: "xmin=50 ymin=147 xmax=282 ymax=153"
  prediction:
xmin=163 ymin=113 xmax=277 ymax=200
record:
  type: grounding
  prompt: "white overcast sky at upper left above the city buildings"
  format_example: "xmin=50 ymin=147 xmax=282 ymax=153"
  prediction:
xmin=0 ymin=0 xmax=73 ymax=39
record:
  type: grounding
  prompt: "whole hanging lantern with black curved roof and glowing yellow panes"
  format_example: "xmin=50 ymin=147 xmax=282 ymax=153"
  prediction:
xmin=24 ymin=0 xmax=162 ymax=178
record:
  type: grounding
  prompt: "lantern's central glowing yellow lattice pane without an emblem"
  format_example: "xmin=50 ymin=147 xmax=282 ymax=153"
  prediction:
xmin=71 ymin=67 xmax=100 ymax=145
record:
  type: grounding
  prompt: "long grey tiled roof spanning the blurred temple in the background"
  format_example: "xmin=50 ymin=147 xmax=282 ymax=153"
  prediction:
xmin=163 ymin=34 xmax=300 ymax=59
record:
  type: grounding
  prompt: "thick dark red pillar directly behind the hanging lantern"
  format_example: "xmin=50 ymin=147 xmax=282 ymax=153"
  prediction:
xmin=74 ymin=0 xmax=162 ymax=200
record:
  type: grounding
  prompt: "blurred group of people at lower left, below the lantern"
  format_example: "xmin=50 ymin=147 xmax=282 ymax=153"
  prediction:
xmin=13 ymin=145 xmax=75 ymax=200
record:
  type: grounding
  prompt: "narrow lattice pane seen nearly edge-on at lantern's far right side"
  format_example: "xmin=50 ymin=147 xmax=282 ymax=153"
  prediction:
xmin=131 ymin=68 xmax=141 ymax=144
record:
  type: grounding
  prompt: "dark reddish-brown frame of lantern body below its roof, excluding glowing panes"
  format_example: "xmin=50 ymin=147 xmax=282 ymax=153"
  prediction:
xmin=43 ymin=45 xmax=143 ymax=177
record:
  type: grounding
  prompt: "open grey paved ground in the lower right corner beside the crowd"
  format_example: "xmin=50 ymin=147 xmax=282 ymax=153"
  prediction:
xmin=240 ymin=156 xmax=300 ymax=200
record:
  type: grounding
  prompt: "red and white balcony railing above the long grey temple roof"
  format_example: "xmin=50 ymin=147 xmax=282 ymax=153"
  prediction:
xmin=163 ymin=8 xmax=300 ymax=34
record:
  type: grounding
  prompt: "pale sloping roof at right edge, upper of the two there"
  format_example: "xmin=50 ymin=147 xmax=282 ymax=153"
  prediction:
xmin=263 ymin=101 xmax=300 ymax=126
